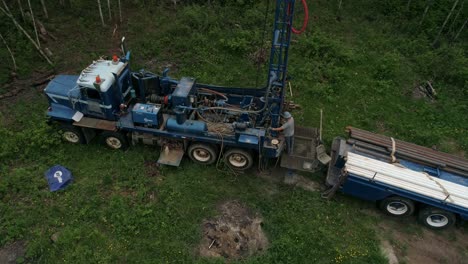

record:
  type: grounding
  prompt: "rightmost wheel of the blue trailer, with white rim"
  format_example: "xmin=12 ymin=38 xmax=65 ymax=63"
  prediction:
xmin=418 ymin=207 xmax=456 ymax=229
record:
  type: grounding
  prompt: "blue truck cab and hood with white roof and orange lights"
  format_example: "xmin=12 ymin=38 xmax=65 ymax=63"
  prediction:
xmin=44 ymin=56 xmax=131 ymax=122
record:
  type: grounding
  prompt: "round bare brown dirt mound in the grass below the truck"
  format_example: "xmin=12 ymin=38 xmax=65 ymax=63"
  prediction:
xmin=199 ymin=201 xmax=268 ymax=259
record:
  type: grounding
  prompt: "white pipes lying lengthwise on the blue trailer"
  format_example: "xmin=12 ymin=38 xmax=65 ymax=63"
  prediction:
xmin=345 ymin=152 xmax=468 ymax=208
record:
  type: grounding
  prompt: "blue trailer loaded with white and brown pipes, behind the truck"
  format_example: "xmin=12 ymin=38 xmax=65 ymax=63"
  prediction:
xmin=324 ymin=128 xmax=468 ymax=229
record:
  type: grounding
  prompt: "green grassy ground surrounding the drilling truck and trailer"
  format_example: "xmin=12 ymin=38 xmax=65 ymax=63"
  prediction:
xmin=0 ymin=1 xmax=468 ymax=263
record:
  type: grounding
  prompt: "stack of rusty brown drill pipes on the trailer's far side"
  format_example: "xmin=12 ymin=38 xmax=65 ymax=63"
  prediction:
xmin=346 ymin=127 xmax=468 ymax=177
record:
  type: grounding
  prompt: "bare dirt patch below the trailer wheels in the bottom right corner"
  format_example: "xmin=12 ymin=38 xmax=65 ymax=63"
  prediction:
xmin=378 ymin=221 xmax=468 ymax=264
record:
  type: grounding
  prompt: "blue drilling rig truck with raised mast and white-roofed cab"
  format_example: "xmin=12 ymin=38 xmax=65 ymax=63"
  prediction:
xmin=45 ymin=0 xmax=319 ymax=171
